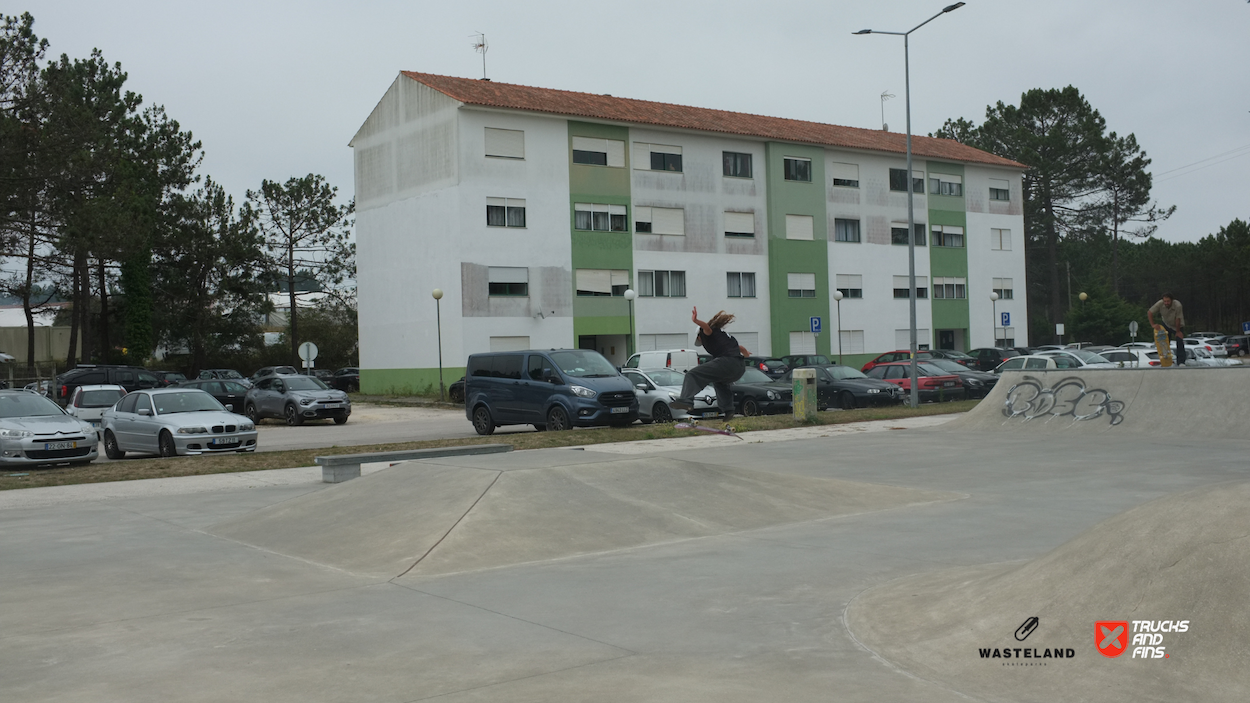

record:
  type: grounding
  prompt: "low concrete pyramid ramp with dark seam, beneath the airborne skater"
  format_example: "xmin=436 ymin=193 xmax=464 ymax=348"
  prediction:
xmin=209 ymin=449 xmax=963 ymax=577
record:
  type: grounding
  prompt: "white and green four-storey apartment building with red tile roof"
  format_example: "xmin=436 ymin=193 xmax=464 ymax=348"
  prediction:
xmin=351 ymin=73 xmax=1028 ymax=393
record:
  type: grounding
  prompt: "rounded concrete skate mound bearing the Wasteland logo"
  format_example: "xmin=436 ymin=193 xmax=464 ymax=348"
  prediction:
xmin=846 ymin=483 xmax=1250 ymax=703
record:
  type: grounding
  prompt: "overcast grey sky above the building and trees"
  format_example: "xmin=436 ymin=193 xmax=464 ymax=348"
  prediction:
xmin=17 ymin=0 xmax=1250 ymax=241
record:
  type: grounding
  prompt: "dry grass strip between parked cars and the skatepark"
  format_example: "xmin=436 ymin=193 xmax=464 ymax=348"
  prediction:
xmin=0 ymin=400 xmax=978 ymax=490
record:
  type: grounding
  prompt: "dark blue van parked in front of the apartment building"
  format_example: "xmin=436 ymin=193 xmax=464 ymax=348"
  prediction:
xmin=465 ymin=349 xmax=638 ymax=434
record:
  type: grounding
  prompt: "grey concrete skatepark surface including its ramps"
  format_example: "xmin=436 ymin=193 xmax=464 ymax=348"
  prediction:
xmin=0 ymin=369 xmax=1250 ymax=703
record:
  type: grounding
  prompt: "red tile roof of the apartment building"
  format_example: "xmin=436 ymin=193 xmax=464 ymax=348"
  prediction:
xmin=403 ymin=71 xmax=1028 ymax=169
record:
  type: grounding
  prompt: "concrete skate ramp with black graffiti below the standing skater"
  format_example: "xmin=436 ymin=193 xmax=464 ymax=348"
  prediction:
xmin=944 ymin=367 xmax=1250 ymax=439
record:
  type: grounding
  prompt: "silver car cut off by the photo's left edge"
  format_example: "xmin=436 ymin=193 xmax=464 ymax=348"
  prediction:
xmin=0 ymin=390 xmax=99 ymax=468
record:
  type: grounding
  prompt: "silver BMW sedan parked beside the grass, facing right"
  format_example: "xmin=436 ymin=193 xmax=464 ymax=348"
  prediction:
xmin=101 ymin=387 xmax=256 ymax=459
